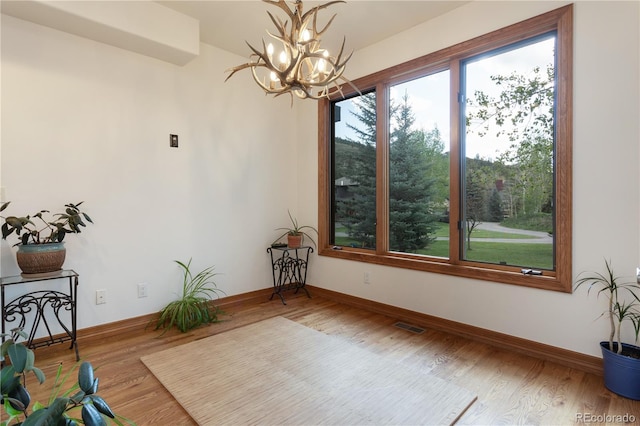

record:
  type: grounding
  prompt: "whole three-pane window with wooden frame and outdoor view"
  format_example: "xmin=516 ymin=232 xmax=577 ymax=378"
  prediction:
xmin=319 ymin=6 xmax=572 ymax=291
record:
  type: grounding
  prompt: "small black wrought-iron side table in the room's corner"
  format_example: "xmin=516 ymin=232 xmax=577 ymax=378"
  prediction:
xmin=267 ymin=246 xmax=313 ymax=305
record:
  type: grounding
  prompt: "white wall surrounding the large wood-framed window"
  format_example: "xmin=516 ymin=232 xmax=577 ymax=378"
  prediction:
xmin=299 ymin=1 xmax=640 ymax=355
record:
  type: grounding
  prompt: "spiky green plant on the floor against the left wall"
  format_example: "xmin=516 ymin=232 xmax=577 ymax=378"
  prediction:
xmin=156 ymin=259 xmax=224 ymax=333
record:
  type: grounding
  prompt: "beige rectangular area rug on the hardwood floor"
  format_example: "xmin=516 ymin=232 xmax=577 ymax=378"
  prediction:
xmin=141 ymin=317 xmax=476 ymax=425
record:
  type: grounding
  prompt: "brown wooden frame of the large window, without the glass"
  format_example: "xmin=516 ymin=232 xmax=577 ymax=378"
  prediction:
xmin=318 ymin=5 xmax=573 ymax=293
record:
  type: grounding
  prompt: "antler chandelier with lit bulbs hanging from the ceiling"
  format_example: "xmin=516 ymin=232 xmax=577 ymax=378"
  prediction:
xmin=225 ymin=0 xmax=357 ymax=102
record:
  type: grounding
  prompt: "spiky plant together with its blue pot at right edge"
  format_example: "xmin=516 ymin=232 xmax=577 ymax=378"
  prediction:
xmin=576 ymin=260 xmax=640 ymax=400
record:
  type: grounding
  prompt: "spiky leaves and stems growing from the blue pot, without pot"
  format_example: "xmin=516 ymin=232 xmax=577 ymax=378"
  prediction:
xmin=576 ymin=259 xmax=640 ymax=354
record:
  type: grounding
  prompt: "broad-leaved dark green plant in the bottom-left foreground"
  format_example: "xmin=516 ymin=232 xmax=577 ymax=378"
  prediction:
xmin=0 ymin=329 xmax=134 ymax=426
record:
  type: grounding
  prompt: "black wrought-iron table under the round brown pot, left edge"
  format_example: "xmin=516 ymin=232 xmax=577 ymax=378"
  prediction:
xmin=0 ymin=269 xmax=80 ymax=361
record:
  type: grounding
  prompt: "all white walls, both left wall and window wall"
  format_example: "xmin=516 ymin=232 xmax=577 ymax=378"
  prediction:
xmin=0 ymin=2 xmax=640 ymax=355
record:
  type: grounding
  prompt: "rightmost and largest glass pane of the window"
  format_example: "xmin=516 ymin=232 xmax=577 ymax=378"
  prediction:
xmin=460 ymin=35 xmax=557 ymax=272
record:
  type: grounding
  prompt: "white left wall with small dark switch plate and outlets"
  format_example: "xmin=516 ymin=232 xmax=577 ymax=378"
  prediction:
xmin=0 ymin=15 xmax=297 ymax=328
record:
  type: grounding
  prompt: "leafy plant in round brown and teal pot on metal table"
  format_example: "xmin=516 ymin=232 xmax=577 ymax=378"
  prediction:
xmin=0 ymin=201 xmax=93 ymax=274
